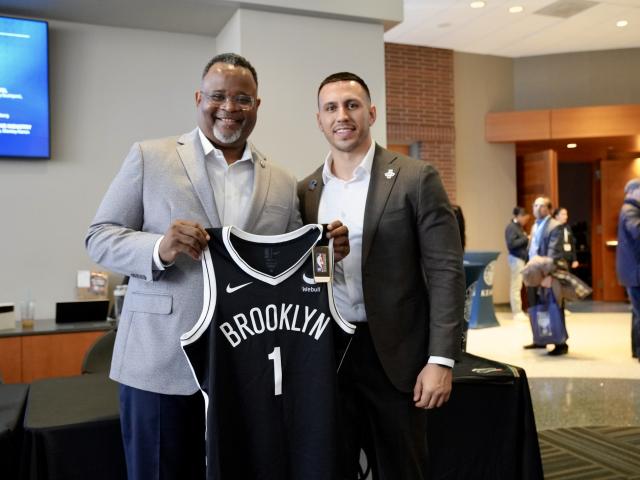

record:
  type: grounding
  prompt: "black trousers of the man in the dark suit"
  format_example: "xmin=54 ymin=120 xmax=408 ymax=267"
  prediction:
xmin=338 ymin=324 xmax=428 ymax=480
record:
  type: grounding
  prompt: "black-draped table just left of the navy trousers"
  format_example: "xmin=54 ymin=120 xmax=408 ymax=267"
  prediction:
xmin=21 ymin=374 xmax=126 ymax=480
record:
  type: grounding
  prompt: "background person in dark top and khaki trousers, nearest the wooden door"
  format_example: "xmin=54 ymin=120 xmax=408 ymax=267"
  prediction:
xmin=504 ymin=207 xmax=529 ymax=321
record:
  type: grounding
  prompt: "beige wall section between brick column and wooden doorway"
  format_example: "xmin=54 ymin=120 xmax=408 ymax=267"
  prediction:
xmin=453 ymin=52 xmax=516 ymax=303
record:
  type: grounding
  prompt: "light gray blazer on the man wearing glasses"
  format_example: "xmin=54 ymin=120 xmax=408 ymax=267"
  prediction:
xmin=85 ymin=129 xmax=302 ymax=395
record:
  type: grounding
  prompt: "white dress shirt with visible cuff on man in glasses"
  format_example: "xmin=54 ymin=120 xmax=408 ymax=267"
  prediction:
xmin=153 ymin=129 xmax=254 ymax=270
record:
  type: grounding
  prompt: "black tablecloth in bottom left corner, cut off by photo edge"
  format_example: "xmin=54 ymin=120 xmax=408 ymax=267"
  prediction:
xmin=0 ymin=384 xmax=29 ymax=479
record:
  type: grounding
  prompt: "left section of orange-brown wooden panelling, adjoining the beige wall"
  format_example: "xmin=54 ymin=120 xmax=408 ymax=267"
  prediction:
xmin=485 ymin=110 xmax=551 ymax=142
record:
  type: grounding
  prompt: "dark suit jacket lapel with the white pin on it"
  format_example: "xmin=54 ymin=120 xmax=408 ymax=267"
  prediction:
xmin=362 ymin=145 xmax=400 ymax=266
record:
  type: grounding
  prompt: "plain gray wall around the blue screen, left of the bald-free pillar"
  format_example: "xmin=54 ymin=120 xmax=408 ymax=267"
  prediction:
xmin=0 ymin=21 xmax=215 ymax=318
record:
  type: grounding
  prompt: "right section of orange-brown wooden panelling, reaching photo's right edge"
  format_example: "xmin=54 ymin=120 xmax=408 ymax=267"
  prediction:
xmin=551 ymin=105 xmax=640 ymax=139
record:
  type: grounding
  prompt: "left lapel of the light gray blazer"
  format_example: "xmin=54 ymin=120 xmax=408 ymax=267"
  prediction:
xmin=177 ymin=128 xmax=220 ymax=227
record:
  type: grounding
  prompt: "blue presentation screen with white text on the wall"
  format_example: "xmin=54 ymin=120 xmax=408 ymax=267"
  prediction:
xmin=0 ymin=17 xmax=50 ymax=158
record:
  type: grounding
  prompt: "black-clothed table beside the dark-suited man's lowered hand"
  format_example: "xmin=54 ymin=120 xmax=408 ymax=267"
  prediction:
xmin=427 ymin=353 xmax=544 ymax=480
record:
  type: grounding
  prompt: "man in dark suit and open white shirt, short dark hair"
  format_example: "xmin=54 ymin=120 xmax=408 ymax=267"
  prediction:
xmin=298 ymin=72 xmax=464 ymax=480
